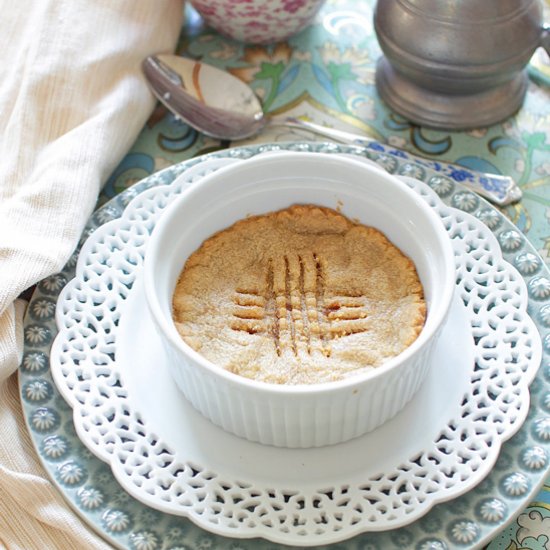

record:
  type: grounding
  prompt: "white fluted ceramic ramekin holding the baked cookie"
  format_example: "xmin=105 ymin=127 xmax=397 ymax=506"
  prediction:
xmin=144 ymin=152 xmax=455 ymax=447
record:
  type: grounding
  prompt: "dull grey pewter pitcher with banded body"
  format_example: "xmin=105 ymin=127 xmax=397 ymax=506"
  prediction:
xmin=374 ymin=0 xmax=550 ymax=129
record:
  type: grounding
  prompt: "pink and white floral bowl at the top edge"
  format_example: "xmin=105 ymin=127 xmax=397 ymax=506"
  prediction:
xmin=191 ymin=0 xmax=325 ymax=44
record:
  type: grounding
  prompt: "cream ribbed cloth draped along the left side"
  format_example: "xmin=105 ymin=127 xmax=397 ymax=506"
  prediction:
xmin=0 ymin=0 xmax=183 ymax=550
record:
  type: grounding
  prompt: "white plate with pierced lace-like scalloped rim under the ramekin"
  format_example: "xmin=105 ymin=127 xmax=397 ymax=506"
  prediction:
xmin=50 ymin=155 xmax=541 ymax=546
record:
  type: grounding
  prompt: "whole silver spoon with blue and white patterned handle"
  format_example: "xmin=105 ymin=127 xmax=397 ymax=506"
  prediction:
xmin=142 ymin=55 xmax=521 ymax=205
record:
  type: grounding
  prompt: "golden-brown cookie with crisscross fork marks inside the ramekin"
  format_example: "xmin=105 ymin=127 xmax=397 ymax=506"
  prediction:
xmin=173 ymin=205 xmax=426 ymax=384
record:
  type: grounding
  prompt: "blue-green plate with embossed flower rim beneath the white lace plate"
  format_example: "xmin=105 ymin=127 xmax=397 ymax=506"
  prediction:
xmin=19 ymin=143 xmax=550 ymax=550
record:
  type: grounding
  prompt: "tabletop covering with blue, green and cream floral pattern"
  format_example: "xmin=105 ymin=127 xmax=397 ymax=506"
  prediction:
xmin=94 ymin=0 xmax=550 ymax=550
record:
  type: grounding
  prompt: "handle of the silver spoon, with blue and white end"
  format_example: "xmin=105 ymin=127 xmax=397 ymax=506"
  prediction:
xmin=282 ymin=117 xmax=522 ymax=206
